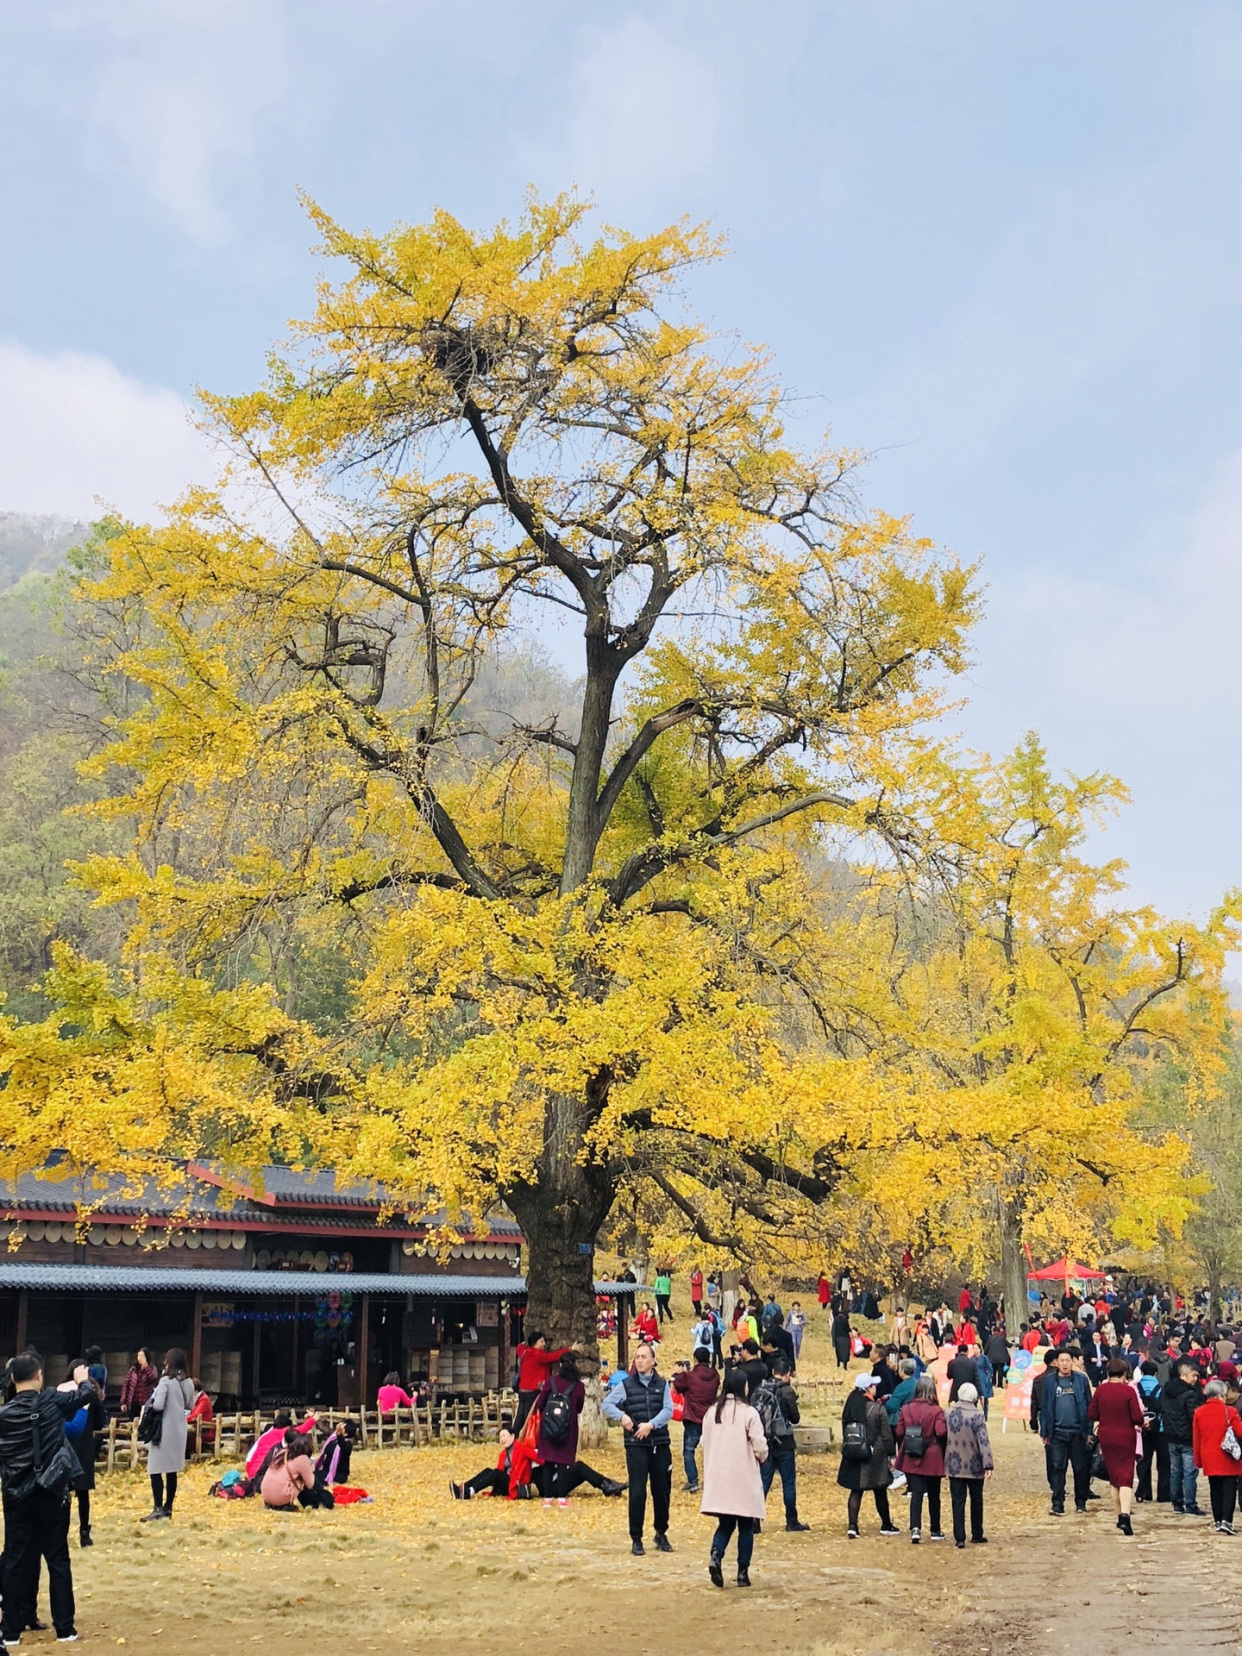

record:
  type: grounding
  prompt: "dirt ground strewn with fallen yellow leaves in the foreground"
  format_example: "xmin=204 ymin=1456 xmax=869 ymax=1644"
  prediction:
xmin=53 ymin=1423 xmax=1242 ymax=1656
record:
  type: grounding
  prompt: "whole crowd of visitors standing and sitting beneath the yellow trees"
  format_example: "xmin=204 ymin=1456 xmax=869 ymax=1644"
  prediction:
xmin=0 ymin=1270 xmax=1242 ymax=1629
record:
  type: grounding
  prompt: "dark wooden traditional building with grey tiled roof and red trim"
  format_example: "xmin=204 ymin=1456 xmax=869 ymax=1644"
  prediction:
xmin=0 ymin=1164 xmax=525 ymax=1408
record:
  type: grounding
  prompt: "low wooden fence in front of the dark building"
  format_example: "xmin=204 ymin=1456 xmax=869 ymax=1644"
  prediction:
xmin=96 ymin=1391 xmax=518 ymax=1472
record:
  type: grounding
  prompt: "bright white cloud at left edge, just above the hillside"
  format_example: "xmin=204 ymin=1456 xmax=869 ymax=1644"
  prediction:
xmin=0 ymin=344 xmax=214 ymax=518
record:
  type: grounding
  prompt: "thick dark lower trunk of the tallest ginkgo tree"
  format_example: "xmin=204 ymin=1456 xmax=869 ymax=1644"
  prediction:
xmin=507 ymin=1098 xmax=616 ymax=1449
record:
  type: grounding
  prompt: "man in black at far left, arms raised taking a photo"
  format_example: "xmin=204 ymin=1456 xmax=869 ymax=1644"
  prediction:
xmin=0 ymin=1353 xmax=94 ymax=1644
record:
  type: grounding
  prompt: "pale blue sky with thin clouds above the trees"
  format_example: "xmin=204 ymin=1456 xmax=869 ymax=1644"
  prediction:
xmin=0 ymin=0 xmax=1242 ymax=912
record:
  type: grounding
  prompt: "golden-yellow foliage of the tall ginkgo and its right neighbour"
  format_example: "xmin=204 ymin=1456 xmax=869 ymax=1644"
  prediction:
xmin=0 ymin=197 xmax=1234 ymax=1350
